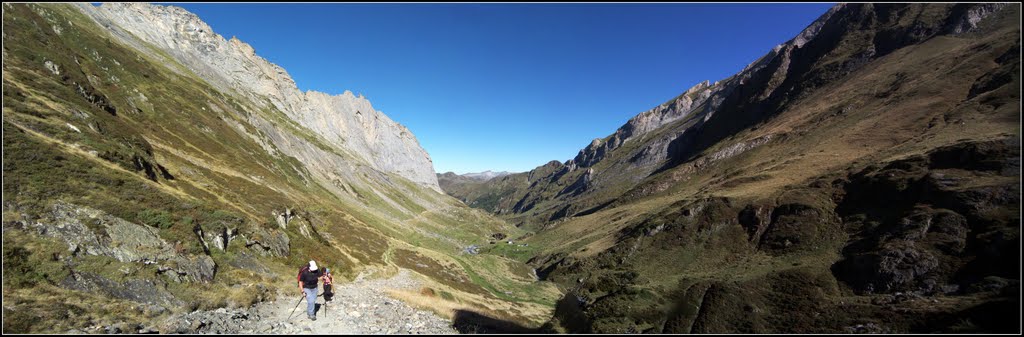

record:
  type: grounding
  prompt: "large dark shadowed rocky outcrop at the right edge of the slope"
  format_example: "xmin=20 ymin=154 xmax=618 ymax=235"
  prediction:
xmin=833 ymin=139 xmax=1020 ymax=294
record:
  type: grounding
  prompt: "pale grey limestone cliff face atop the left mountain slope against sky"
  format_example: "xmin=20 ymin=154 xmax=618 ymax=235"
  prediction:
xmin=72 ymin=3 xmax=440 ymax=191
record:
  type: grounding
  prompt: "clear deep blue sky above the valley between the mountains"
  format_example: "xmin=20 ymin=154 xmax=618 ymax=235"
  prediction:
xmin=174 ymin=3 xmax=833 ymax=173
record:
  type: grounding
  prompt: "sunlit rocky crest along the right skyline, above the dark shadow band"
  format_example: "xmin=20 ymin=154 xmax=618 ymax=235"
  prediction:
xmin=436 ymin=5 xmax=842 ymax=225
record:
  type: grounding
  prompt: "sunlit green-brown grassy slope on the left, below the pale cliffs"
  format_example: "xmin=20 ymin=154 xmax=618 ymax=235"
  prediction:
xmin=3 ymin=4 xmax=560 ymax=332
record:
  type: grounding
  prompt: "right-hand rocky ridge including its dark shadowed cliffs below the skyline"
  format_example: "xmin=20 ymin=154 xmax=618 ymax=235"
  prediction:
xmin=453 ymin=4 xmax=1015 ymax=226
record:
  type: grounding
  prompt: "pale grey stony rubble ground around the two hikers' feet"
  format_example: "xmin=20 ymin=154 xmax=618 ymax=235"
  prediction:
xmin=160 ymin=269 xmax=458 ymax=334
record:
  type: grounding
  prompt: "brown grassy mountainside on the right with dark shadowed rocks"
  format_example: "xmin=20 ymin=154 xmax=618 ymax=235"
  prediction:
xmin=454 ymin=4 xmax=1020 ymax=333
